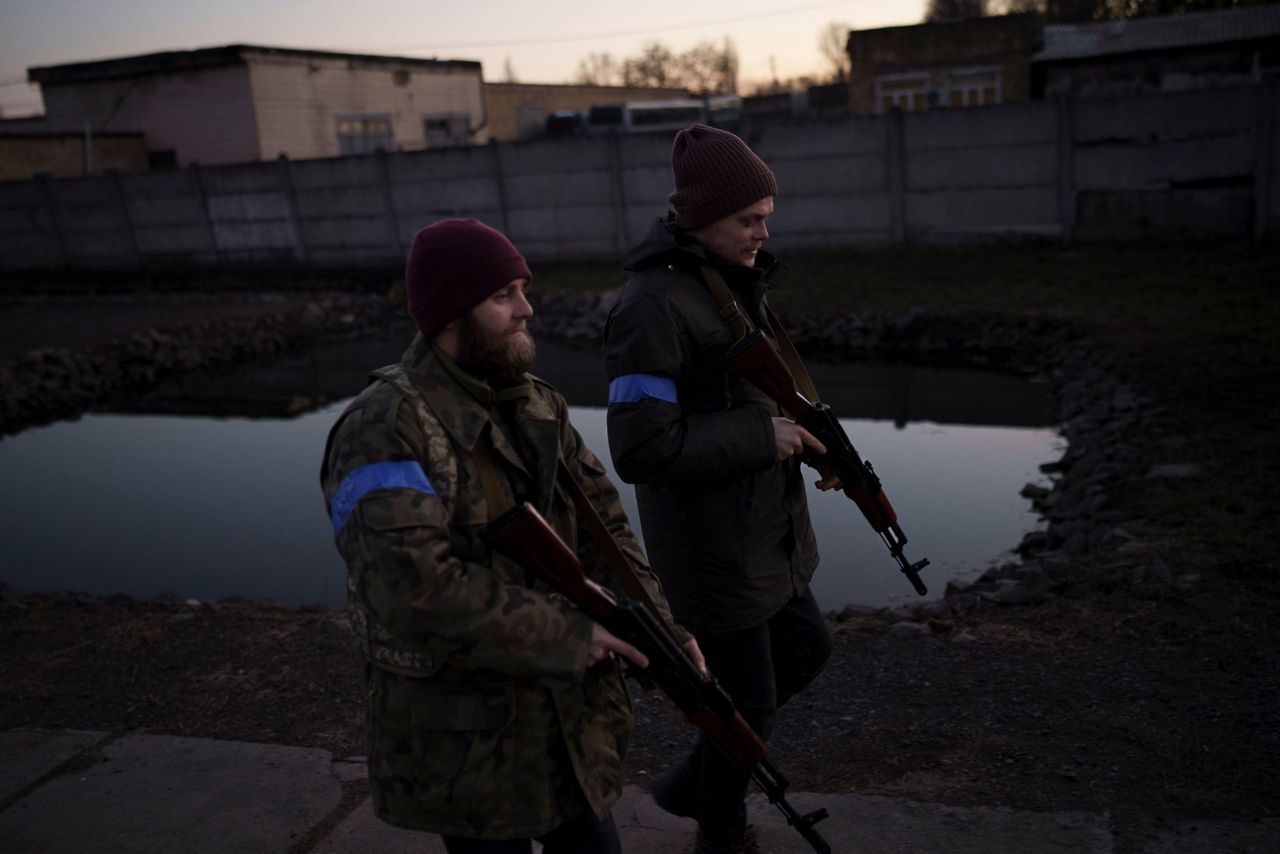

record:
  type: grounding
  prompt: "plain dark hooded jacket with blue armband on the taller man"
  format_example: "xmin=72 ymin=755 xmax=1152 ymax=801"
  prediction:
xmin=604 ymin=222 xmax=818 ymax=632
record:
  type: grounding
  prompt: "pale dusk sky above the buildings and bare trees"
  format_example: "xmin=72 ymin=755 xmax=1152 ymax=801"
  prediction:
xmin=0 ymin=0 xmax=924 ymax=118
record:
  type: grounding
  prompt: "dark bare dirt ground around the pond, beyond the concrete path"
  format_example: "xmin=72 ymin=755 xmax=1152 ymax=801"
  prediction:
xmin=0 ymin=290 xmax=1280 ymax=851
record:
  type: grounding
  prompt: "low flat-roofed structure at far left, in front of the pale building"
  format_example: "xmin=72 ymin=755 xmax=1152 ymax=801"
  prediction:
xmin=0 ymin=132 xmax=147 ymax=181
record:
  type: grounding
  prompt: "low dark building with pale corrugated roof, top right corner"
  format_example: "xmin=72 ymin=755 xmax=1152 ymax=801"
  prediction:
xmin=1032 ymin=5 xmax=1280 ymax=97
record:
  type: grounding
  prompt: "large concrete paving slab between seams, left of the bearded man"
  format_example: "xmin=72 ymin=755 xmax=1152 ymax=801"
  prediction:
xmin=0 ymin=735 xmax=342 ymax=854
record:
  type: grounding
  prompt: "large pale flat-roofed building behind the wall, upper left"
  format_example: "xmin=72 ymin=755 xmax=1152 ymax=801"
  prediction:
xmin=27 ymin=45 xmax=488 ymax=166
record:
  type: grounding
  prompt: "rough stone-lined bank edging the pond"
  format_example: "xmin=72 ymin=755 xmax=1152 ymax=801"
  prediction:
xmin=0 ymin=291 xmax=1199 ymax=640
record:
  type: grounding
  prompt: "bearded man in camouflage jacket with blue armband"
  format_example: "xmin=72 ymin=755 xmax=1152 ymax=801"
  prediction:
xmin=321 ymin=219 xmax=701 ymax=854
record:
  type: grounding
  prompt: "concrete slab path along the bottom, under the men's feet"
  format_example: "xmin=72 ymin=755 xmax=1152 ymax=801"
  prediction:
xmin=0 ymin=730 xmax=1280 ymax=854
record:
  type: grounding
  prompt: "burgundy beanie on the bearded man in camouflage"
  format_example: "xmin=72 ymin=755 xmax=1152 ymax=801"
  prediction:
xmin=404 ymin=219 xmax=534 ymax=338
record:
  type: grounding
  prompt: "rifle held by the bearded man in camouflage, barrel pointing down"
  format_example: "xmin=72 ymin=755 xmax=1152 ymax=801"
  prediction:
xmin=480 ymin=502 xmax=831 ymax=854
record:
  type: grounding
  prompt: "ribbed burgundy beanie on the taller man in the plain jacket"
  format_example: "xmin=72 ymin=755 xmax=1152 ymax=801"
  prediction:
xmin=667 ymin=124 xmax=778 ymax=230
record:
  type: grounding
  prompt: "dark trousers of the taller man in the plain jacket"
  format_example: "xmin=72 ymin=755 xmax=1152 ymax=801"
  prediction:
xmin=686 ymin=590 xmax=831 ymax=837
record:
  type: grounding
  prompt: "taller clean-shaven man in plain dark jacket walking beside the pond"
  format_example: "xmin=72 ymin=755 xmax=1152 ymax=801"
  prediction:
xmin=604 ymin=124 xmax=838 ymax=854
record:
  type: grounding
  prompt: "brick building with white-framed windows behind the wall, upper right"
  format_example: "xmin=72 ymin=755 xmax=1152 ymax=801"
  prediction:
xmin=846 ymin=15 xmax=1039 ymax=113
